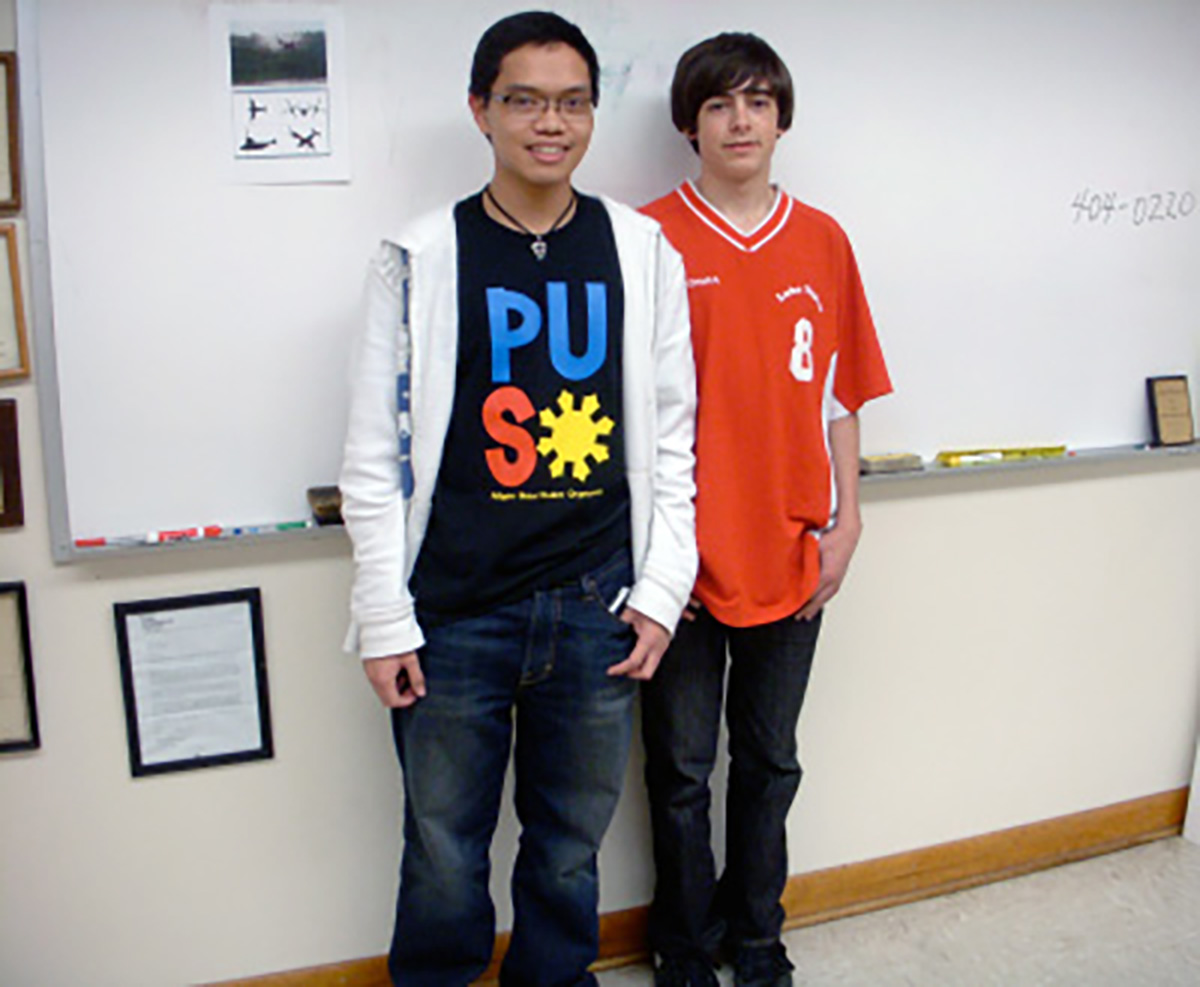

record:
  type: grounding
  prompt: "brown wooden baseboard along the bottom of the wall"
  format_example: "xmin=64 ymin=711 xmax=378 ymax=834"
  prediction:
xmin=210 ymin=788 xmax=1188 ymax=987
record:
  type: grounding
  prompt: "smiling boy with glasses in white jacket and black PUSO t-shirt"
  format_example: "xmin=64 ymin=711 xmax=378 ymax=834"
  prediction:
xmin=341 ymin=11 xmax=696 ymax=987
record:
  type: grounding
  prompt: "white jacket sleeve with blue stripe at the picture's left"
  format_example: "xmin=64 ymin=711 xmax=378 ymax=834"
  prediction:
xmin=338 ymin=244 xmax=425 ymax=658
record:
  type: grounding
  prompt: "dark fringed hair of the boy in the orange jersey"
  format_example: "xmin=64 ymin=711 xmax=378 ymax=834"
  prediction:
xmin=671 ymin=31 xmax=796 ymax=146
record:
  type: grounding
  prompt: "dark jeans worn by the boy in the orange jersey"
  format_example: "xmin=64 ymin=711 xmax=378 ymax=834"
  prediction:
xmin=642 ymin=611 xmax=821 ymax=956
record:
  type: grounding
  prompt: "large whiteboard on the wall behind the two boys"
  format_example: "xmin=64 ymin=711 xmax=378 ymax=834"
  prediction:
xmin=18 ymin=0 xmax=1200 ymax=557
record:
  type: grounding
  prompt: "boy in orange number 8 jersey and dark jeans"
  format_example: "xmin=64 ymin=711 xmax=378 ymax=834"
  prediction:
xmin=642 ymin=34 xmax=890 ymax=987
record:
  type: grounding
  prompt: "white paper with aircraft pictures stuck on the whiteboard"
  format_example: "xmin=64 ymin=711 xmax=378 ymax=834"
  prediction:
xmin=210 ymin=4 xmax=350 ymax=185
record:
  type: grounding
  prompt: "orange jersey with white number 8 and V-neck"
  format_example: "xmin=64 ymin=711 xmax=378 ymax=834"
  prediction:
xmin=643 ymin=183 xmax=892 ymax=627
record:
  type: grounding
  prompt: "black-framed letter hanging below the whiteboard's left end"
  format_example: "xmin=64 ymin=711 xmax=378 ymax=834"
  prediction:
xmin=113 ymin=588 xmax=274 ymax=778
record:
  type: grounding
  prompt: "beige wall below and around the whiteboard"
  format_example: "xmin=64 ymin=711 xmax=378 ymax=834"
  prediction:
xmin=0 ymin=0 xmax=1200 ymax=987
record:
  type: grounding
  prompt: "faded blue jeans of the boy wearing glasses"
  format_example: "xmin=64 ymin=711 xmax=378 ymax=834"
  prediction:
xmin=389 ymin=552 xmax=636 ymax=987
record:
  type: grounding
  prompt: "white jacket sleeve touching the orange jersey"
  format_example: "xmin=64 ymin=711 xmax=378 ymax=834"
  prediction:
xmin=629 ymin=232 xmax=698 ymax=632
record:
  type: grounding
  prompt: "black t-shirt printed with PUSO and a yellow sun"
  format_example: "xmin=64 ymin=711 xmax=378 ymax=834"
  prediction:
xmin=412 ymin=195 xmax=630 ymax=617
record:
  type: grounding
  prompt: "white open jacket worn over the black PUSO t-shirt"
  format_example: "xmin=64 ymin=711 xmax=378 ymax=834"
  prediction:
xmin=338 ymin=198 xmax=697 ymax=658
